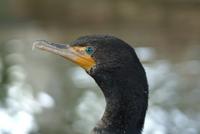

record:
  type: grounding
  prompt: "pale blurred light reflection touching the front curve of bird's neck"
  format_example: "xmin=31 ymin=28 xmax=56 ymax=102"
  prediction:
xmin=73 ymin=90 xmax=105 ymax=133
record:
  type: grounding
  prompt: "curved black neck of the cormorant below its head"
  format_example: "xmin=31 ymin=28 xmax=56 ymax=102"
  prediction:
xmin=91 ymin=69 xmax=148 ymax=134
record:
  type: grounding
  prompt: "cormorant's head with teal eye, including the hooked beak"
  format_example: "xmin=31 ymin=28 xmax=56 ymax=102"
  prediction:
xmin=33 ymin=35 xmax=137 ymax=73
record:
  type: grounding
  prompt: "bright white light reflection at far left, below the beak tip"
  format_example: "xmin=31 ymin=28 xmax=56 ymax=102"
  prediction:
xmin=0 ymin=58 xmax=54 ymax=134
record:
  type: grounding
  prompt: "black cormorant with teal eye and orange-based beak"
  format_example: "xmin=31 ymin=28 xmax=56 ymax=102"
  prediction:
xmin=33 ymin=35 xmax=148 ymax=134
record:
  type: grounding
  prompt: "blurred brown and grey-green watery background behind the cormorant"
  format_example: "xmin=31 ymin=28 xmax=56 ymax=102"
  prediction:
xmin=0 ymin=0 xmax=200 ymax=134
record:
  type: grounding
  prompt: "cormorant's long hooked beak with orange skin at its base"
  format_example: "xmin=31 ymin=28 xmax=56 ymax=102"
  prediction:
xmin=33 ymin=40 xmax=96 ymax=71
